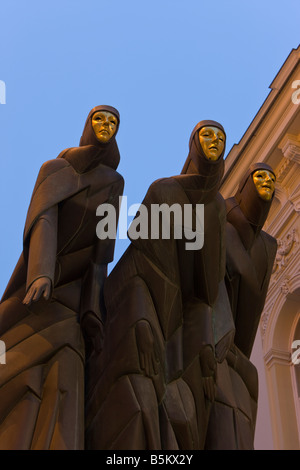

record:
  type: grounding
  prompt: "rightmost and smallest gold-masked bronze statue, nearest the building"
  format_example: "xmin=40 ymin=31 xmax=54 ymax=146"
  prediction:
xmin=206 ymin=163 xmax=277 ymax=450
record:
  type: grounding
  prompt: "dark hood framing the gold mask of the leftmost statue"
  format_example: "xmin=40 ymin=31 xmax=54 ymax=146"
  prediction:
xmin=63 ymin=105 xmax=120 ymax=173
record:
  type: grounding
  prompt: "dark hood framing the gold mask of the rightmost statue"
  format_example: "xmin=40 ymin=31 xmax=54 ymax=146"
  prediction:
xmin=234 ymin=163 xmax=276 ymax=232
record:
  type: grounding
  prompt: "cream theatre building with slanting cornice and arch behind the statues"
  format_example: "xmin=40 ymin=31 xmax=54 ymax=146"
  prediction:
xmin=221 ymin=46 xmax=300 ymax=450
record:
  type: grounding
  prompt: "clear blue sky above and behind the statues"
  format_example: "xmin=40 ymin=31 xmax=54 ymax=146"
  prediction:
xmin=0 ymin=0 xmax=300 ymax=295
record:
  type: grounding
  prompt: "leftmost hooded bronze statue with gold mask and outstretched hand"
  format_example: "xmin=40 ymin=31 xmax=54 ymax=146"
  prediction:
xmin=0 ymin=106 xmax=123 ymax=450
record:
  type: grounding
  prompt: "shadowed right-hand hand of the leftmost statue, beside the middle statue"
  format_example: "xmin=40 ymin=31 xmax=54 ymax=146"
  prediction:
xmin=80 ymin=311 xmax=104 ymax=354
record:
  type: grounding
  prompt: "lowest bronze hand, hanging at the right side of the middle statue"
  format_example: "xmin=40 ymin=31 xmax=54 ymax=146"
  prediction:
xmin=199 ymin=345 xmax=217 ymax=402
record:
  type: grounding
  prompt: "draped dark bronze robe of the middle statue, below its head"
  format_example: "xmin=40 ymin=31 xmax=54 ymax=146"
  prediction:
xmin=87 ymin=121 xmax=232 ymax=450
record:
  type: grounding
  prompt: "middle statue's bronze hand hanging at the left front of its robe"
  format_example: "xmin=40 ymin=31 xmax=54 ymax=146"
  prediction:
xmin=135 ymin=320 xmax=158 ymax=377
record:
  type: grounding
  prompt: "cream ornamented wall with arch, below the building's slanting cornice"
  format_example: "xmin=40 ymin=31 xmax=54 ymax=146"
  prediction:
xmin=260 ymin=130 xmax=300 ymax=449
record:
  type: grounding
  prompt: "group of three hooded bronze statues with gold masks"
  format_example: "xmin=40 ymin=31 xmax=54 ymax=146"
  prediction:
xmin=0 ymin=106 xmax=276 ymax=450
